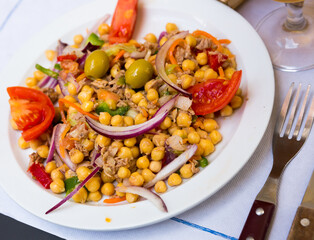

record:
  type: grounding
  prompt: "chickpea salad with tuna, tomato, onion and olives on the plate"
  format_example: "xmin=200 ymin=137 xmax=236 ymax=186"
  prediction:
xmin=7 ymin=0 xmax=243 ymax=214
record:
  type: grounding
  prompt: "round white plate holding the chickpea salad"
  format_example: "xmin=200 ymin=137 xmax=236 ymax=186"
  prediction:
xmin=0 ymin=0 xmax=274 ymax=230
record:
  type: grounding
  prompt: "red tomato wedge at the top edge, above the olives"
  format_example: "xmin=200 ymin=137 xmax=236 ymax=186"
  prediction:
xmin=109 ymin=0 xmax=137 ymax=44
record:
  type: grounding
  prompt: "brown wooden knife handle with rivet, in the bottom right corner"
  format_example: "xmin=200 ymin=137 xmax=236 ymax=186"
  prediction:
xmin=287 ymin=206 xmax=314 ymax=240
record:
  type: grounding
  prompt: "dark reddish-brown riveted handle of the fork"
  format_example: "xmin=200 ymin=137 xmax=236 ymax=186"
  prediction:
xmin=239 ymin=200 xmax=275 ymax=240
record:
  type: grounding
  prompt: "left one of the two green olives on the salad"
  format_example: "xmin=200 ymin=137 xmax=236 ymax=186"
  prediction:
xmin=84 ymin=50 xmax=109 ymax=78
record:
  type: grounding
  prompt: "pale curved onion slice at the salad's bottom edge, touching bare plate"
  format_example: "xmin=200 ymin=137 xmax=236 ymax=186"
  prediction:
xmin=116 ymin=186 xmax=168 ymax=212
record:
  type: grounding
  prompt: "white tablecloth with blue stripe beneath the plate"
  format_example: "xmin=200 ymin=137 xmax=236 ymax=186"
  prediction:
xmin=0 ymin=0 xmax=314 ymax=240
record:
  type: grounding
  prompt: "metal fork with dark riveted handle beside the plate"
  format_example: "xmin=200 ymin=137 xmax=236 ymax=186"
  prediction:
xmin=239 ymin=83 xmax=314 ymax=240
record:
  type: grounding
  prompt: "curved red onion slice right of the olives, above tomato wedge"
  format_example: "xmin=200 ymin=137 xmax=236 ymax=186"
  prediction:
xmin=156 ymin=31 xmax=192 ymax=97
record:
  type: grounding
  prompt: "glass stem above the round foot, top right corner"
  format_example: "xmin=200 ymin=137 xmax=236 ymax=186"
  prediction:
xmin=283 ymin=2 xmax=307 ymax=31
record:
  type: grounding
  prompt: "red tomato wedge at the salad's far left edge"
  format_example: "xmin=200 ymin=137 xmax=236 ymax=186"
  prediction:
xmin=7 ymin=87 xmax=55 ymax=141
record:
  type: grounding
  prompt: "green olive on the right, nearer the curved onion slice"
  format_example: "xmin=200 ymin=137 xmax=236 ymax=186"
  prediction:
xmin=125 ymin=59 xmax=154 ymax=88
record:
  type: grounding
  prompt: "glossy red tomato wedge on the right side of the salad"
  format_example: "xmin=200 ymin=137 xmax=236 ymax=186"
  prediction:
xmin=188 ymin=70 xmax=242 ymax=115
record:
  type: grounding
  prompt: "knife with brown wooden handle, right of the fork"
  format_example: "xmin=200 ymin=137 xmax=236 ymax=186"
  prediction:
xmin=287 ymin=171 xmax=314 ymax=240
